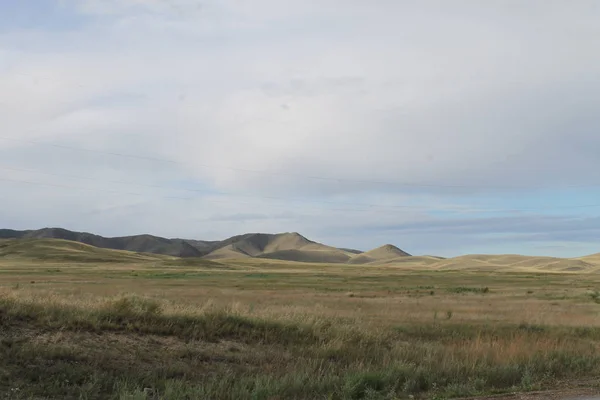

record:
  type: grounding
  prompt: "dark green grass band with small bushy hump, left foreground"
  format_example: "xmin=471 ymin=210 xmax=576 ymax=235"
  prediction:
xmin=0 ymin=297 xmax=326 ymax=344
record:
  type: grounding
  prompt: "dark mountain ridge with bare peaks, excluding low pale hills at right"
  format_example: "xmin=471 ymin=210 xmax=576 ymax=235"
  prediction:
xmin=0 ymin=228 xmax=410 ymax=264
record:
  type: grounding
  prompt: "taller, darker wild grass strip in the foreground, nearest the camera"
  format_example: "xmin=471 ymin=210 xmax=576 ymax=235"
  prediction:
xmin=0 ymin=294 xmax=600 ymax=400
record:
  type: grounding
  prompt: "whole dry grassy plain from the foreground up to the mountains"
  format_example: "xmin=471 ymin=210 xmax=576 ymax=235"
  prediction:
xmin=0 ymin=240 xmax=600 ymax=399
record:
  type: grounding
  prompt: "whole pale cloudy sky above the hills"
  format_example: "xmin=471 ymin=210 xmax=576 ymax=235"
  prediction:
xmin=0 ymin=0 xmax=600 ymax=257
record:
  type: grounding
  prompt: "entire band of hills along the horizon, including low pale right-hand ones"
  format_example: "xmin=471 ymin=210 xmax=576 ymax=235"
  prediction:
xmin=0 ymin=228 xmax=600 ymax=273
